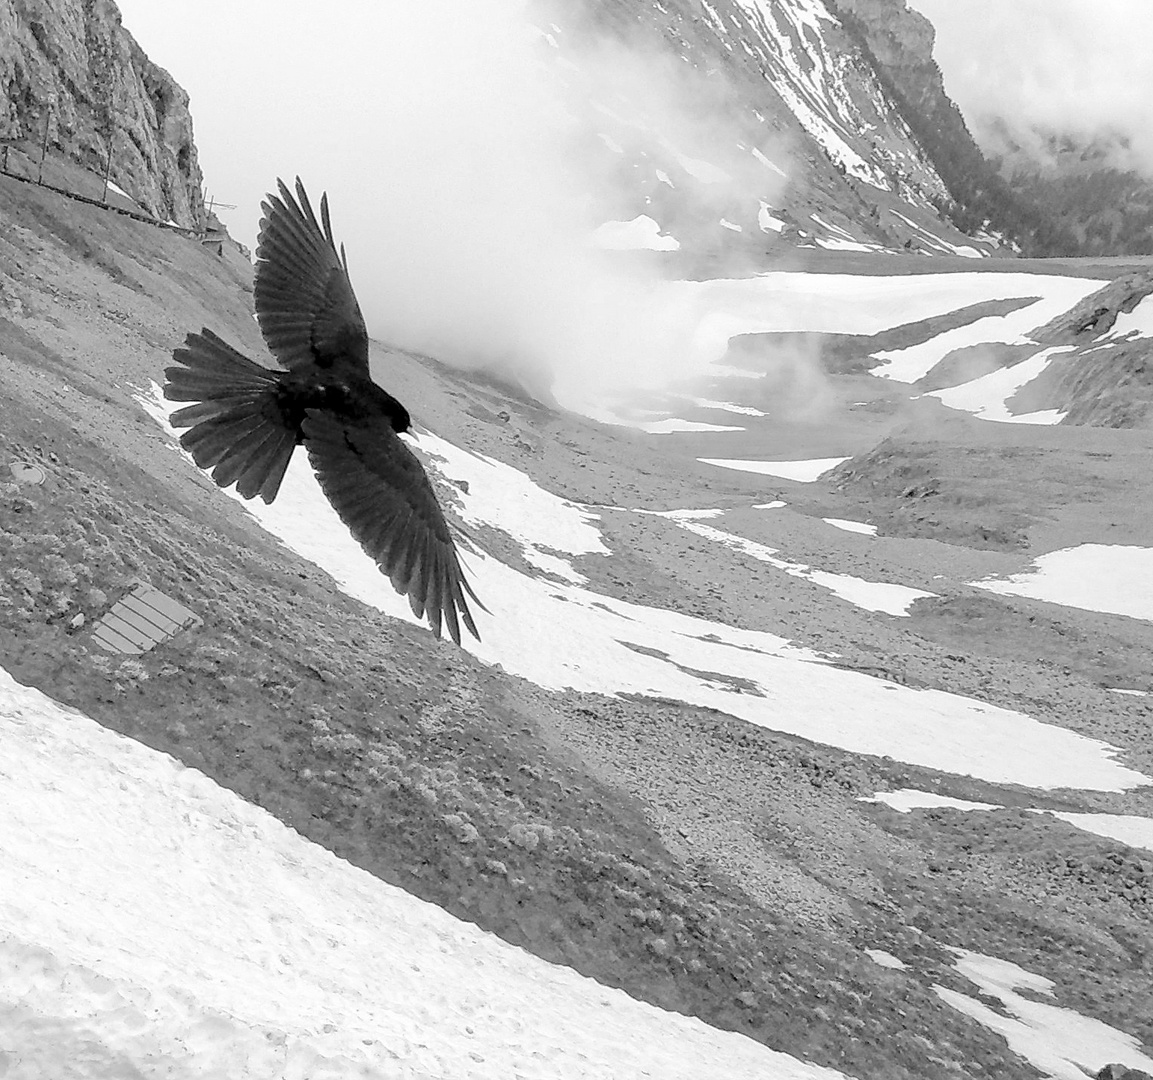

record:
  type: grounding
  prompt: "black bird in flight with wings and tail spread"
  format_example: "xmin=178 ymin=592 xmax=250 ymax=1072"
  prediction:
xmin=164 ymin=178 xmax=484 ymax=644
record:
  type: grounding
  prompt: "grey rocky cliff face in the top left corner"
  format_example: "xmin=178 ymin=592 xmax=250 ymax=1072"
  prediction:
xmin=0 ymin=0 xmax=204 ymax=227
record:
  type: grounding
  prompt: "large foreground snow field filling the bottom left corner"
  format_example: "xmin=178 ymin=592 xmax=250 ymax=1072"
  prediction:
xmin=0 ymin=669 xmax=841 ymax=1080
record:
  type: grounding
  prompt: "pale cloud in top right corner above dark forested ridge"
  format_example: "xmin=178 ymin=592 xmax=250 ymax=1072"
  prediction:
xmin=910 ymin=0 xmax=1153 ymax=175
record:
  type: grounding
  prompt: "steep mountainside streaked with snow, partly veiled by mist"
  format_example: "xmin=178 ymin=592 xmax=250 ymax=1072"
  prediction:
xmin=553 ymin=0 xmax=998 ymax=264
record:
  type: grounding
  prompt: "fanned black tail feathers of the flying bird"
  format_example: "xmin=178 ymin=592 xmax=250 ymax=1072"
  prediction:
xmin=164 ymin=330 xmax=297 ymax=503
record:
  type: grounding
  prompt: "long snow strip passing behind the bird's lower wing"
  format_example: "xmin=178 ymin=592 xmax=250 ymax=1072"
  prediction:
xmin=138 ymin=385 xmax=1150 ymax=791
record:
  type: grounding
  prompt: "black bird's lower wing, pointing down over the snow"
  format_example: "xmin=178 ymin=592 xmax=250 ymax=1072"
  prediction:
xmin=303 ymin=409 xmax=484 ymax=644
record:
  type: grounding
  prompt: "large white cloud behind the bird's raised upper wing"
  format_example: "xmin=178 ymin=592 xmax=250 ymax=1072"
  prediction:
xmin=112 ymin=0 xmax=781 ymax=408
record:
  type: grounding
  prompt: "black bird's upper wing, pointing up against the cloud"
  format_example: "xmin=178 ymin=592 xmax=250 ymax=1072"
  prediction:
xmin=255 ymin=176 xmax=368 ymax=376
